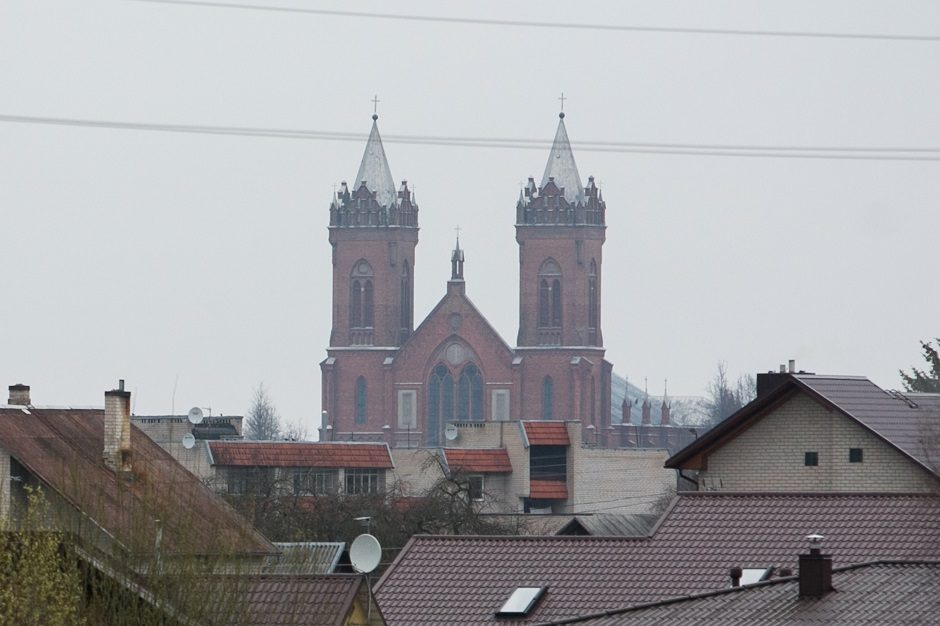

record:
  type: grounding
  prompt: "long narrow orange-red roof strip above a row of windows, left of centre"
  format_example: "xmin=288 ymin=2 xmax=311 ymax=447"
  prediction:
xmin=209 ymin=441 xmax=394 ymax=469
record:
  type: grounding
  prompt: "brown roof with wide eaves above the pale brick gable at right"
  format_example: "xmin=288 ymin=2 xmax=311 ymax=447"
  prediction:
xmin=666 ymin=374 xmax=940 ymax=475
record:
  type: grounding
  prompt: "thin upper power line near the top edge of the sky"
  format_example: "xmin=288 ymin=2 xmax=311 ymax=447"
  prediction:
xmin=131 ymin=0 xmax=940 ymax=43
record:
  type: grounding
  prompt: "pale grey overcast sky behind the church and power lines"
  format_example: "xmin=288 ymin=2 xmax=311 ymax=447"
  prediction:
xmin=0 ymin=0 xmax=940 ymax=426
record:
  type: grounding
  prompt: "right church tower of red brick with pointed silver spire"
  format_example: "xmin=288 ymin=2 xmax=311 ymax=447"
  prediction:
xmin=516 ymin=113 xmax=606 ymax=347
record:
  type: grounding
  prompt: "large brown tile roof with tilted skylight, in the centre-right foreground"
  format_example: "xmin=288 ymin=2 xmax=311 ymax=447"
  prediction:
xmin=377 ymin=492 xmax=940 ymax=626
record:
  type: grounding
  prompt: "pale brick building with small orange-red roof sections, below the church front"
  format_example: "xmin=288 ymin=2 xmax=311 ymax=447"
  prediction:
xmin=391 ymin=420 xmax=676 ymax=515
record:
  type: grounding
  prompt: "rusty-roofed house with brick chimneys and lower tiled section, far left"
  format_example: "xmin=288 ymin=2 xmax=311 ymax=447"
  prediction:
xmin=0 ymin=381 xmax=388 ymax=626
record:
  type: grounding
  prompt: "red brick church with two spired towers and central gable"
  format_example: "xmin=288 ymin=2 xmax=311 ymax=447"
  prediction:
xmin=320 ymin=113 xmax=618 ymax=447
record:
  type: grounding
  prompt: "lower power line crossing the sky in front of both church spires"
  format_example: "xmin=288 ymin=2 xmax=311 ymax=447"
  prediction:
xmin=0 ymin=114 xmax=940 ymax=161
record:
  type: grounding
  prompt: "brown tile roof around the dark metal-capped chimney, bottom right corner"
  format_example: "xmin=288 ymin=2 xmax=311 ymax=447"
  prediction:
xmin=551 ymin=561 xmax=940 ymax=626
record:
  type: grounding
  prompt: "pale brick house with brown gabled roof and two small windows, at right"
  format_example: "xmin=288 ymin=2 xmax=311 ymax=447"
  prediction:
xmin=666 ymin=372 xmax=940 ymax=493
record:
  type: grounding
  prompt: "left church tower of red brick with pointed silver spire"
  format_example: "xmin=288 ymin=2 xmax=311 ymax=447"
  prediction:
xmin=329 ymin=115 xmax=418 ymax=347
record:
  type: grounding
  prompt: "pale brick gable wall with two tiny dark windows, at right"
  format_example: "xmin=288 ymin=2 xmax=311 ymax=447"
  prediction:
xmin=699 ymin=394 xmax=938 ymax=492
